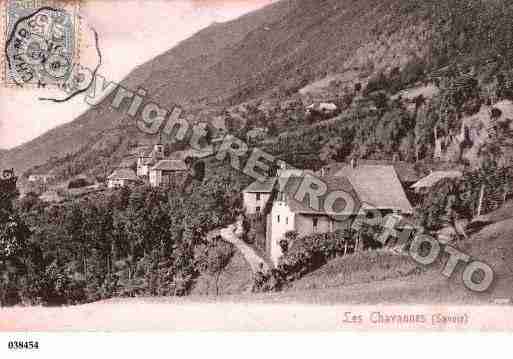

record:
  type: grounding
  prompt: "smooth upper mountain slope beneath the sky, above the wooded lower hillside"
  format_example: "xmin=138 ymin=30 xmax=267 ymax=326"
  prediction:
xmin=0 ymin=0 xmax=513 ymax=177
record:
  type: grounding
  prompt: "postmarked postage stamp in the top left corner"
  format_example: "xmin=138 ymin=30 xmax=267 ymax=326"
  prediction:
xmin=2 ymin=0 xmax=80 ymax=87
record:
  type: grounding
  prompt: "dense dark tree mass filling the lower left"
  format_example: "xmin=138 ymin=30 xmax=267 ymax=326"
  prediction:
xmin=0 ymin=170 xmax=244 ymax=305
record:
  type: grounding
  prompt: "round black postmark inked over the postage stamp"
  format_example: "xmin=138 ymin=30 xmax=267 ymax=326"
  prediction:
xmin=5 ymin=7 xmax=75 ymax=87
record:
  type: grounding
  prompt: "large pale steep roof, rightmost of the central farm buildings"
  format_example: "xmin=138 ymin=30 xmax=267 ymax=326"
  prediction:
xmin=335 ymin=165 xmax=413 ymax=213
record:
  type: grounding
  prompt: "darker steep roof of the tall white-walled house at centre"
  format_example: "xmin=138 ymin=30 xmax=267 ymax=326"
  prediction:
xmin=278 ymin=177 xmax=361 ymax=215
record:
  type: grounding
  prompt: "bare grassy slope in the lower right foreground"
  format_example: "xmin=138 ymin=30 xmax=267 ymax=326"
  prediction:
xmin=284 ymin=219 xmax=513 ymax=304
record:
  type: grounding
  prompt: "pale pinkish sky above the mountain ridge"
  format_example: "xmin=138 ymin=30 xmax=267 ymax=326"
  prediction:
xmin=0 ymin=0 xmax=272 ymax=149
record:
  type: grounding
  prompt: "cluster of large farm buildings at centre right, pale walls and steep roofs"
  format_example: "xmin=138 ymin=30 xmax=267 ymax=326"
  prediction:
xmin=243 ymin=160 xmax=456 ymax=264
